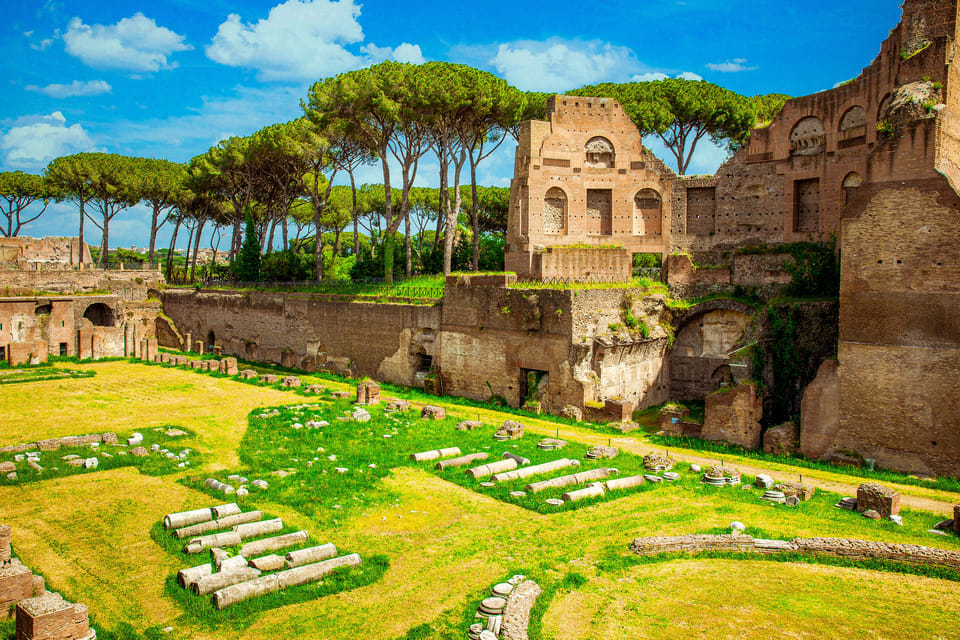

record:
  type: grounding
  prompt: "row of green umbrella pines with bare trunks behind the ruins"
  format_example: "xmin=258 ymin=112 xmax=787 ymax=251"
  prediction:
xmin=0 ymin=62 xmax=787 ymax=281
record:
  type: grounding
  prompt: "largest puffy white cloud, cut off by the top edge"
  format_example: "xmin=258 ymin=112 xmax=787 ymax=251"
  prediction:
xmin=207 ymin=0 xmax=424 ymax=82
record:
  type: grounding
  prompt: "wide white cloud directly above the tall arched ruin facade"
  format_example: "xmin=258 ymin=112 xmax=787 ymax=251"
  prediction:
xmin=488 ymin=38 xmax=642 ymax=91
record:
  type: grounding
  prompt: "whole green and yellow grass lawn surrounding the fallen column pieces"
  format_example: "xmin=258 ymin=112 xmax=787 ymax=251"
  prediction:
xmin=0 ymin=362 xmax=960 ymax=640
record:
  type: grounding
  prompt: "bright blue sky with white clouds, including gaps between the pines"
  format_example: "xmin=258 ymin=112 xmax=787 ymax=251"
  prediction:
xmin=0 ymin=0 xmax=900 ymax=246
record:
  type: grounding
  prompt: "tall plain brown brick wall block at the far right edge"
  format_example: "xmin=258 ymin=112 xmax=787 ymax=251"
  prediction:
xmin=834 ymin=185 xmax=960 ymax=474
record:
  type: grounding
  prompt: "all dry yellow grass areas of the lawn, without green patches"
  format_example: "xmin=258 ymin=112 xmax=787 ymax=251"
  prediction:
xmin=0 ymin=363 xmax=960 ymax=640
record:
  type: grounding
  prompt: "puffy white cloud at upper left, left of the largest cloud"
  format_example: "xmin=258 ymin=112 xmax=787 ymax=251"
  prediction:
xmin=63 ymin=12 xmax=193 ymax=71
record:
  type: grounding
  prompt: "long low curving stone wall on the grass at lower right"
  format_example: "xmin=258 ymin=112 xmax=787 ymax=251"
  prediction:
xmin=630 ymin=534 xmax=960 ymax=568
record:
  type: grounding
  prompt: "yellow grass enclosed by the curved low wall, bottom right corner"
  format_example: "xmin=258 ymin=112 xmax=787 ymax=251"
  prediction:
xmin=544 ymin=560 xmax=960 ymax=640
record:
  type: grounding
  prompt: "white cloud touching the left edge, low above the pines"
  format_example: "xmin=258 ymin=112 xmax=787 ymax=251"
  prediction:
xmin=0 ymin=111 xmax=94 ymax=169
